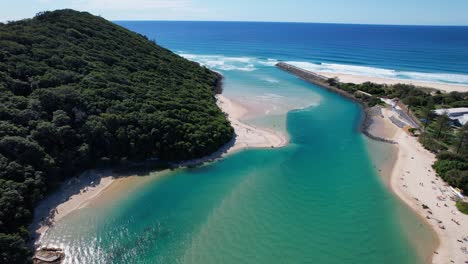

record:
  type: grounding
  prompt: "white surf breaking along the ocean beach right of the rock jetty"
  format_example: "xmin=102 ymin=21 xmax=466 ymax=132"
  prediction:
xmin=288 ymin=61 xmax=468 ymax=84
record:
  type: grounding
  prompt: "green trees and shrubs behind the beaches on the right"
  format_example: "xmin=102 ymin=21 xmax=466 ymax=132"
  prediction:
xmin=328 ymin=78 xmax=468 ymax=206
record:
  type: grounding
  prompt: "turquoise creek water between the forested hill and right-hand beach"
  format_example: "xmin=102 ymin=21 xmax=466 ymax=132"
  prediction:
xmin=39 ymin=81 xmax=428 ymax=263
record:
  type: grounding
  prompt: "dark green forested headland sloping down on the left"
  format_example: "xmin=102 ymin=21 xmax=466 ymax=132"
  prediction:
xmin=0 ymin=10 xmax=234 ymax=263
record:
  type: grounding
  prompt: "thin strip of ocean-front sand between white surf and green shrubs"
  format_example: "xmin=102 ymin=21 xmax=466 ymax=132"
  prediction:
xmin=317 ymin=72 xmax=468 ymax=92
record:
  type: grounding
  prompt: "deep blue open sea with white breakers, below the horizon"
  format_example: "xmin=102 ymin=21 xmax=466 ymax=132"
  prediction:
xmin=117 ymin=21 xmax=468 ymax=84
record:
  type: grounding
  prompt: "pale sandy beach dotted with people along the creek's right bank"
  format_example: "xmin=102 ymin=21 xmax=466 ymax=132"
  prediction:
xmin=374 ymin=106 xmax=468 ymax=264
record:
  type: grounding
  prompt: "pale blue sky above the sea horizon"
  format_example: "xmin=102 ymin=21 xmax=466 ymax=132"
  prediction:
xmin=0 ymin=0 xmax=468 ymax=25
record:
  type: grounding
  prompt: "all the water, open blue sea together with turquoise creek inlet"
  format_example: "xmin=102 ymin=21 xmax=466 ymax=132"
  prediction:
xmin=36 ymin=21 xmax=468 ymax=264
